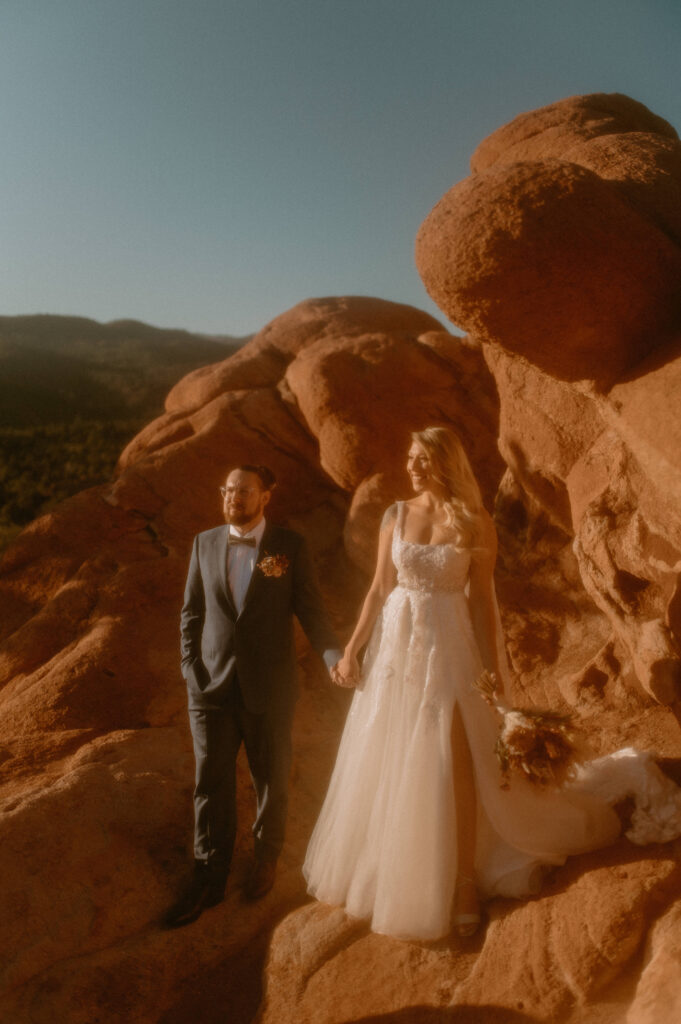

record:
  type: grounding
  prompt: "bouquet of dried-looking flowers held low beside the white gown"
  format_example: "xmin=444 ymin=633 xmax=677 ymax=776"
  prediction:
xmin=474 ymin=672 xmax=576 ymax=790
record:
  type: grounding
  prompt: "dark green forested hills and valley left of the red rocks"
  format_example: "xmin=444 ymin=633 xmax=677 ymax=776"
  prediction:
xmin=0 ymin=315 xmax=246 ymax=551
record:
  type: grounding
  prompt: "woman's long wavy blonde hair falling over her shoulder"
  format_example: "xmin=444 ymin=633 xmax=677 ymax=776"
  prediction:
xmin=412 ymin=427 xmax=483 ymax=548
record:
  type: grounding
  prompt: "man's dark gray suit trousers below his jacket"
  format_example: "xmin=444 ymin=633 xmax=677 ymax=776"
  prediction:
xmin=189 ymin=679 xmax=294 ymax=878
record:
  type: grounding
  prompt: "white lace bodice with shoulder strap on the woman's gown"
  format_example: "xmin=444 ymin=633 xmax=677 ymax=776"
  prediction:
xmin=392 ymin=502 xmax=470 ymax=592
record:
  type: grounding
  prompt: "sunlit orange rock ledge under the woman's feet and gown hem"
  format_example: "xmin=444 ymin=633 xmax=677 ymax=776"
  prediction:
xmin=259 ymin=847 xmax=681 ymax=1024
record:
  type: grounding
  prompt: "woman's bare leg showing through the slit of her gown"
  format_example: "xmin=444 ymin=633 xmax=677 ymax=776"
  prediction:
xmin=452 ymin=705 xmax=480 ymax=935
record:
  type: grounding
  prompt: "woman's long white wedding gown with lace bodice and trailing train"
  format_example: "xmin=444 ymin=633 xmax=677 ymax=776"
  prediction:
xmin=303 ymin=503 xmax=681 ymax=939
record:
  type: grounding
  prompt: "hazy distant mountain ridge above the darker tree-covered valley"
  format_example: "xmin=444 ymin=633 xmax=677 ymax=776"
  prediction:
xmin=0 ymin=313 xmax=248 ymax=427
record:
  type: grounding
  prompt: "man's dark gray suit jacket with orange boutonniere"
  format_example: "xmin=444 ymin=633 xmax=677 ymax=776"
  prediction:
xmin=181 ymin=523 xmax=340 ymax=714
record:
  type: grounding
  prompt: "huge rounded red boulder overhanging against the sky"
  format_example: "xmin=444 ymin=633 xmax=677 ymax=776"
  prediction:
xmin=416 ymin=96 xmax=681 ymax=387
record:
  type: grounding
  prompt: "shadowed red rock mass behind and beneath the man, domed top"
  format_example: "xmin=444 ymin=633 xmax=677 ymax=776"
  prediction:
xmin=0 ymin=298 xmax=503 ymax=1024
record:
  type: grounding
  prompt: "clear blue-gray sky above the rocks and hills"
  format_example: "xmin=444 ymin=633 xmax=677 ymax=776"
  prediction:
xmin=0 ymin=0 xmax=681 ymax=335
